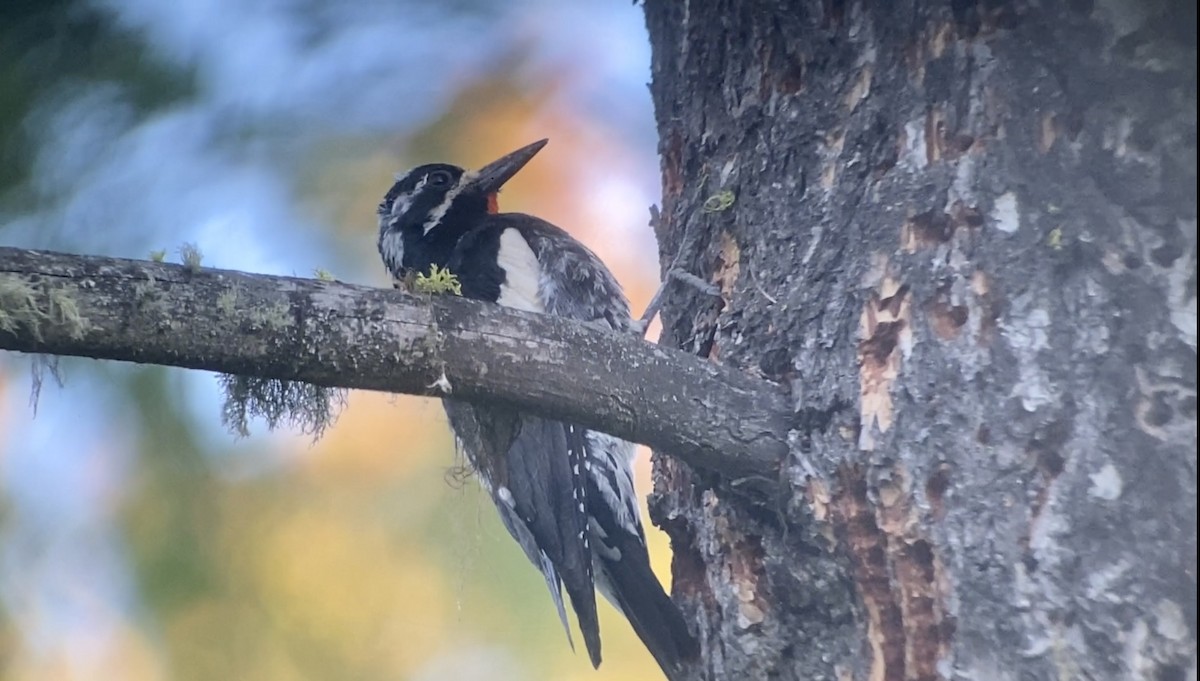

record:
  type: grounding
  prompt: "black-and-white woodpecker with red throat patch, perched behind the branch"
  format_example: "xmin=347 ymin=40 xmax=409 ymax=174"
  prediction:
xmin=378 ymin=139 xmax=698 ymax=680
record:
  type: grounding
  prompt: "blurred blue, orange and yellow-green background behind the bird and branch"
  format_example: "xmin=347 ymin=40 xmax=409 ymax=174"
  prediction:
xmin=0 ymin=0 xmax=668 ymax=681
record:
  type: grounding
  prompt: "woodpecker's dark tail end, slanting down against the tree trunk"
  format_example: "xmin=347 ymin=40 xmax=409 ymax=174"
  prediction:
xmin=596 ymin=537 xmax=700 ymax=681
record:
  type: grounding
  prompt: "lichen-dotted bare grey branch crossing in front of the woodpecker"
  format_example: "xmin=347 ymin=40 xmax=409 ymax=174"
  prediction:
xmin=0 ymin=248 xmax=791 ymax=480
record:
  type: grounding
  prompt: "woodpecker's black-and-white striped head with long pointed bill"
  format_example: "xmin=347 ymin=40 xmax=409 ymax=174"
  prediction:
xmin=378 ymin=139 xmax=547 ymax=278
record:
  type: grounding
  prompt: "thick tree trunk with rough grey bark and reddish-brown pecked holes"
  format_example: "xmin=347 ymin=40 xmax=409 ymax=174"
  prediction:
xmin=646 ymin=0 xmax=1196 ymax=681
